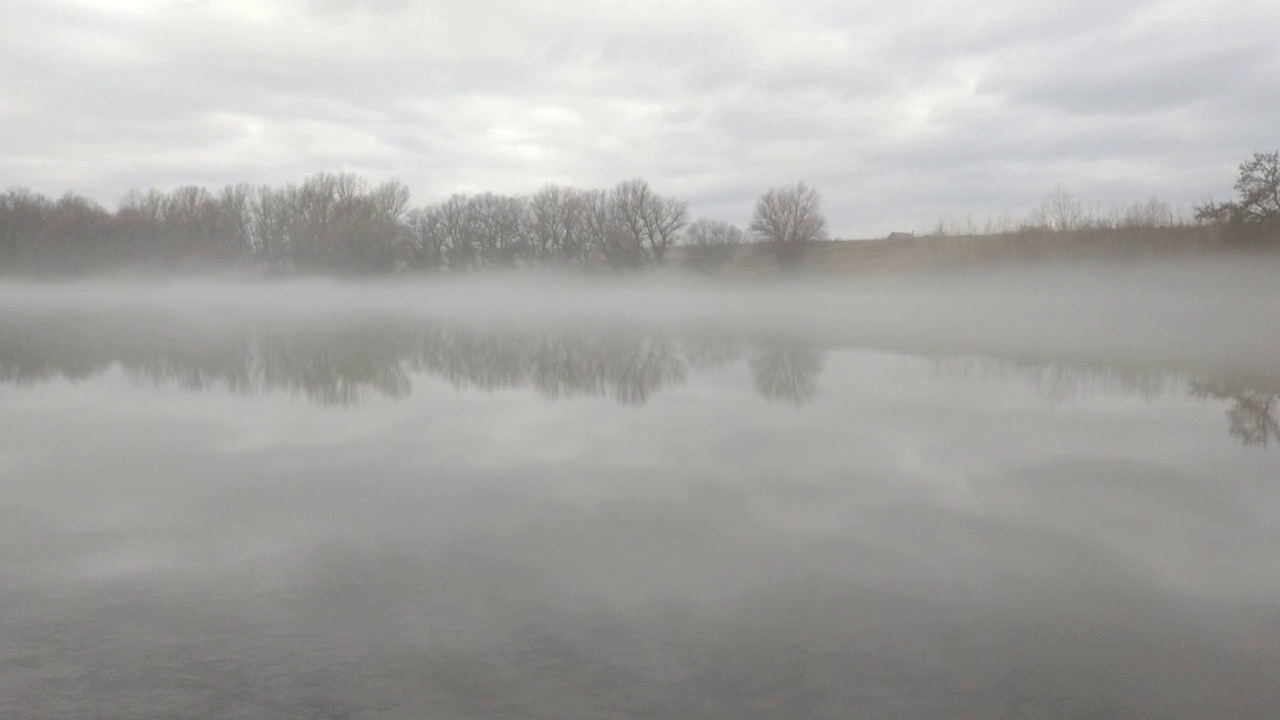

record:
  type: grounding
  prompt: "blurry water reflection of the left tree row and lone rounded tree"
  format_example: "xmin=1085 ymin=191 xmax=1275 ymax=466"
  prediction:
xmin=0 ymin=314 xmax=822 ymax=406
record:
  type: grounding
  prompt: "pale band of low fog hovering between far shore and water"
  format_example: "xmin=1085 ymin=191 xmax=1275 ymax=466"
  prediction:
xmin=0 ymin=254 xmax=1280 ymax=369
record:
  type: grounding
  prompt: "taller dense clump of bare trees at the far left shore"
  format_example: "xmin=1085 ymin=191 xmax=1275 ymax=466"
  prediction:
xmin=0 ymin=173 xmax=408 ymax=272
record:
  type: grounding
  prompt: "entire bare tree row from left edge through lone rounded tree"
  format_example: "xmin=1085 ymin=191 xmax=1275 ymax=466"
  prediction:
xmin=0 ymin=173 xmax=826 ymax=273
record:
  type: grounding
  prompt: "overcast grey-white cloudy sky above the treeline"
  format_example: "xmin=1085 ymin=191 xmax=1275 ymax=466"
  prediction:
xmin=0 ymin=0 xmax=1280 ymax=237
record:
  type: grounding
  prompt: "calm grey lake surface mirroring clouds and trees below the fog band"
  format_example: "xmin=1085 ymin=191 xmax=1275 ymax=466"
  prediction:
xmin=0 ymin=281 xmax=1280 ymax=719
